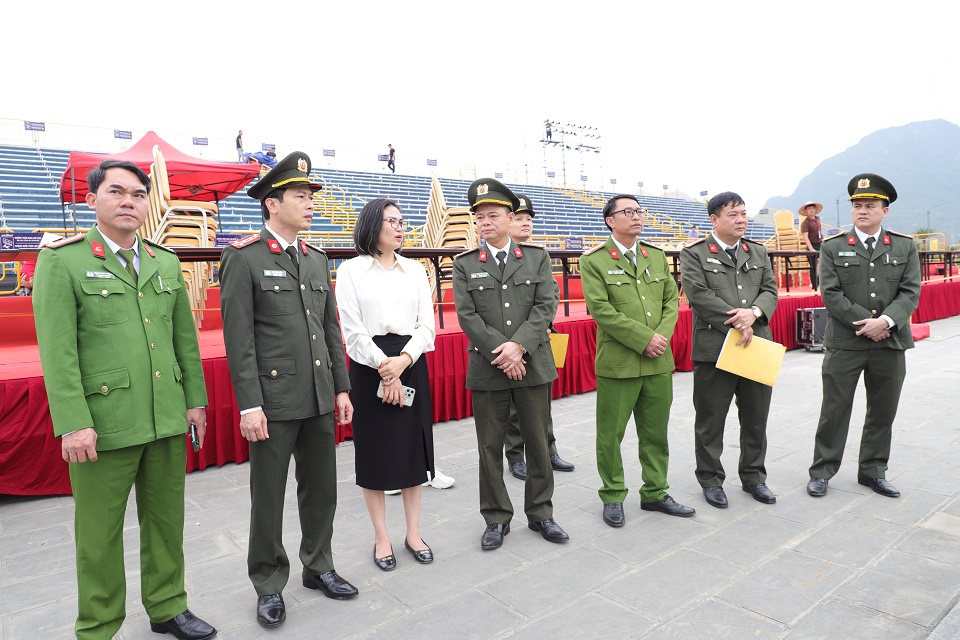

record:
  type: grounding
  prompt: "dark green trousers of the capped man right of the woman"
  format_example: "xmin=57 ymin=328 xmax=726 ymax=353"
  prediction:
xmin=472 ymin=383 xmax=553 ymax=525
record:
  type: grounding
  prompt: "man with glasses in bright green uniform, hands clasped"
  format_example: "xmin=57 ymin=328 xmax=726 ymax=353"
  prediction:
xmin=580 ymin=195 xmax=695 ymax=527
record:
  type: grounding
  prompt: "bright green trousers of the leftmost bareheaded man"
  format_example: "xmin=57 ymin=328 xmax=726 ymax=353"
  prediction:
xmin=70 ymin=436 xmax=187 ymax=640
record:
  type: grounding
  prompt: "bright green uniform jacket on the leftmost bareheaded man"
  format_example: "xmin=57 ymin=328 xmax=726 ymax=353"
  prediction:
xmin=33 ymin=226 xmax=207 ymax=451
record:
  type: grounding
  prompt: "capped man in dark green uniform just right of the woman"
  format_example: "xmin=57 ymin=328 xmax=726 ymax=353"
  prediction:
xmin=453 ymin=178 xmax=569 ymax=550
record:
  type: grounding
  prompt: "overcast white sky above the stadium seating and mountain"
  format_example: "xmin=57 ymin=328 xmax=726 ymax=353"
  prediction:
xmin=0 ymin=0 xmax=960 ymax=211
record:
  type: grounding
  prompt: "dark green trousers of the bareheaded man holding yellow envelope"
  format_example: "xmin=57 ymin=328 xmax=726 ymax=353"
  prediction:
xmin=693 ymin=362 xmax=773 ymax=487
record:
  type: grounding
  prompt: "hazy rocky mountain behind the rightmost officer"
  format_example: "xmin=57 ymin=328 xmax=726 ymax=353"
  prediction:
xmin=765 ymin=120 xmax=960 ymax=242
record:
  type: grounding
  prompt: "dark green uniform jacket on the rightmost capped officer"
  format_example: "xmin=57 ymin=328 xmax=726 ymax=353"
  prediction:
xmin=820 ymin=229 xmax=920 ymax=350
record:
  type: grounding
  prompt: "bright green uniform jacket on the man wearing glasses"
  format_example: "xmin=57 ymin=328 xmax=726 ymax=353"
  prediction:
xmin=580 ymin=237 xmax=678 ymax=378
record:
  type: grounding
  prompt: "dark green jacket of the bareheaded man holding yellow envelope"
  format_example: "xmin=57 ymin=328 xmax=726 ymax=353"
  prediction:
xmin=680 ymin=234 xmax=777 ymax=362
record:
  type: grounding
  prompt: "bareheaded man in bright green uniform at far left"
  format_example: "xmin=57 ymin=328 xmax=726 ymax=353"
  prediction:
xmin=33 ymin=160 xmax=217 ymax=640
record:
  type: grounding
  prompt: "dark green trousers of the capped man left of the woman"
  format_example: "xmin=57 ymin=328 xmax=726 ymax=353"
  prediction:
xmin=247 ymin=412 xmax=337 ymax=596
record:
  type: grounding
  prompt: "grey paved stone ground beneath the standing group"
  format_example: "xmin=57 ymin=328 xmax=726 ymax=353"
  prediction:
xmin=0 ymin=317 xmax=960 ymax=640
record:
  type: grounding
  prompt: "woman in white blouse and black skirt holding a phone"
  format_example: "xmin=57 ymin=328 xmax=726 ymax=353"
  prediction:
xmin=336 ymin=198 xmax=436 ymax=571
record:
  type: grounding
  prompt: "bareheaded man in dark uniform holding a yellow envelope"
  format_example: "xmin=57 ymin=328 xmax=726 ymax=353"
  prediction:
xmin=680 ymin=191 xmax=777 ymax=509
